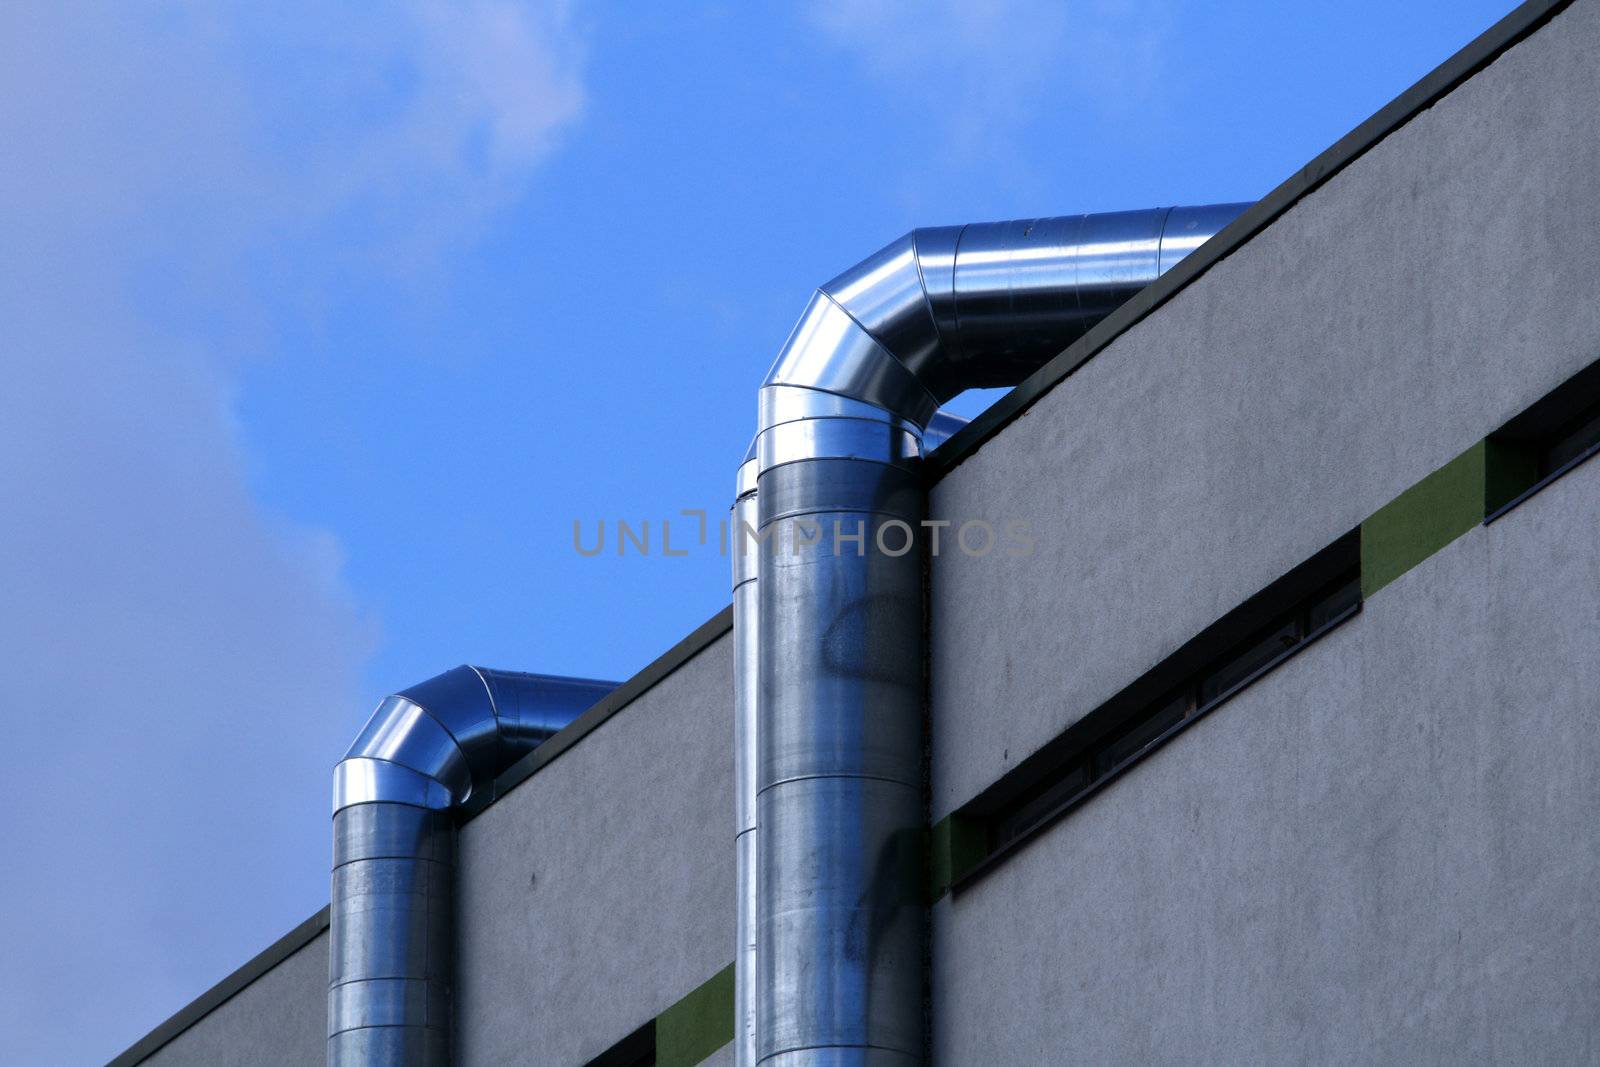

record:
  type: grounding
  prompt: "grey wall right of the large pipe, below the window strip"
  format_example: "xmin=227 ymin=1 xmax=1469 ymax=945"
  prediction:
xmin=933 ymin=461 xmax=1600 ymax=1064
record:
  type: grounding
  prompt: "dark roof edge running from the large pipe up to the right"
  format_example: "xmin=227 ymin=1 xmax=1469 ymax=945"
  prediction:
xmin=923 ymin=0 xmax=1573 ymax=486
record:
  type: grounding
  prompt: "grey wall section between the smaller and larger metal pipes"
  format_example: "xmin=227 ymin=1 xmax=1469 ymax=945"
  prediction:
xmin=456 ymin=637 xmax=733 ymax=1067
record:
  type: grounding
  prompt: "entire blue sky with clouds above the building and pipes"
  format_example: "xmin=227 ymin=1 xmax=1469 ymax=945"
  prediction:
xmin=0 ymin=0 xmax=1510 ymax=1064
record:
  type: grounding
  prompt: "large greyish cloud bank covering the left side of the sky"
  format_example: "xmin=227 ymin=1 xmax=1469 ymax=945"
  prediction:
xmin=0 ymin=0 xmax=584 ymax=1062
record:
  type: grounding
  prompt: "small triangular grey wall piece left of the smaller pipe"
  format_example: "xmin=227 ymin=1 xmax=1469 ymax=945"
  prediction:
xmin=144 ymin=933 xmax=328 ymax=1067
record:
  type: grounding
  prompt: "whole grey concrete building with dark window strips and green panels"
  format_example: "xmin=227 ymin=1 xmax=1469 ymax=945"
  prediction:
xmin=115 ymin=0 xmax=1600 ymax=1067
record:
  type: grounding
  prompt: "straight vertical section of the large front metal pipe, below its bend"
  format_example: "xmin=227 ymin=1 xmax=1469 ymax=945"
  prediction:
xmin=757 ymin=387 xmax=923 ymax=1067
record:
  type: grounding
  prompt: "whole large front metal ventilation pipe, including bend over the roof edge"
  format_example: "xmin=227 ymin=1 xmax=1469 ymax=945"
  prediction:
xmin=748 ymin=203 xmax=1248 ymax=1067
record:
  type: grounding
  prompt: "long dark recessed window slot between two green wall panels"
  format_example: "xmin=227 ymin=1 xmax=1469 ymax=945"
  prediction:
xmin=955 ymin=531 xmax=1362 ymax=888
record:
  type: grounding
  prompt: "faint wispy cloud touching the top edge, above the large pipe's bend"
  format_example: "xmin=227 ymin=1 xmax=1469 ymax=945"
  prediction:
xmin=813 ymin=0 xmax=1171 ymax=158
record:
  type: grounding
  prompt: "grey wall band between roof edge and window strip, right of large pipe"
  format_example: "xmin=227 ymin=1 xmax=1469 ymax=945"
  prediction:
xmin=931 ymin=0 xmax=1600 ymax=819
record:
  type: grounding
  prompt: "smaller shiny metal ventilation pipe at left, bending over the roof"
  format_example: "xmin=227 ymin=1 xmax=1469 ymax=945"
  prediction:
xmin=328 ymin=667 xmax=616 ymax=1067
